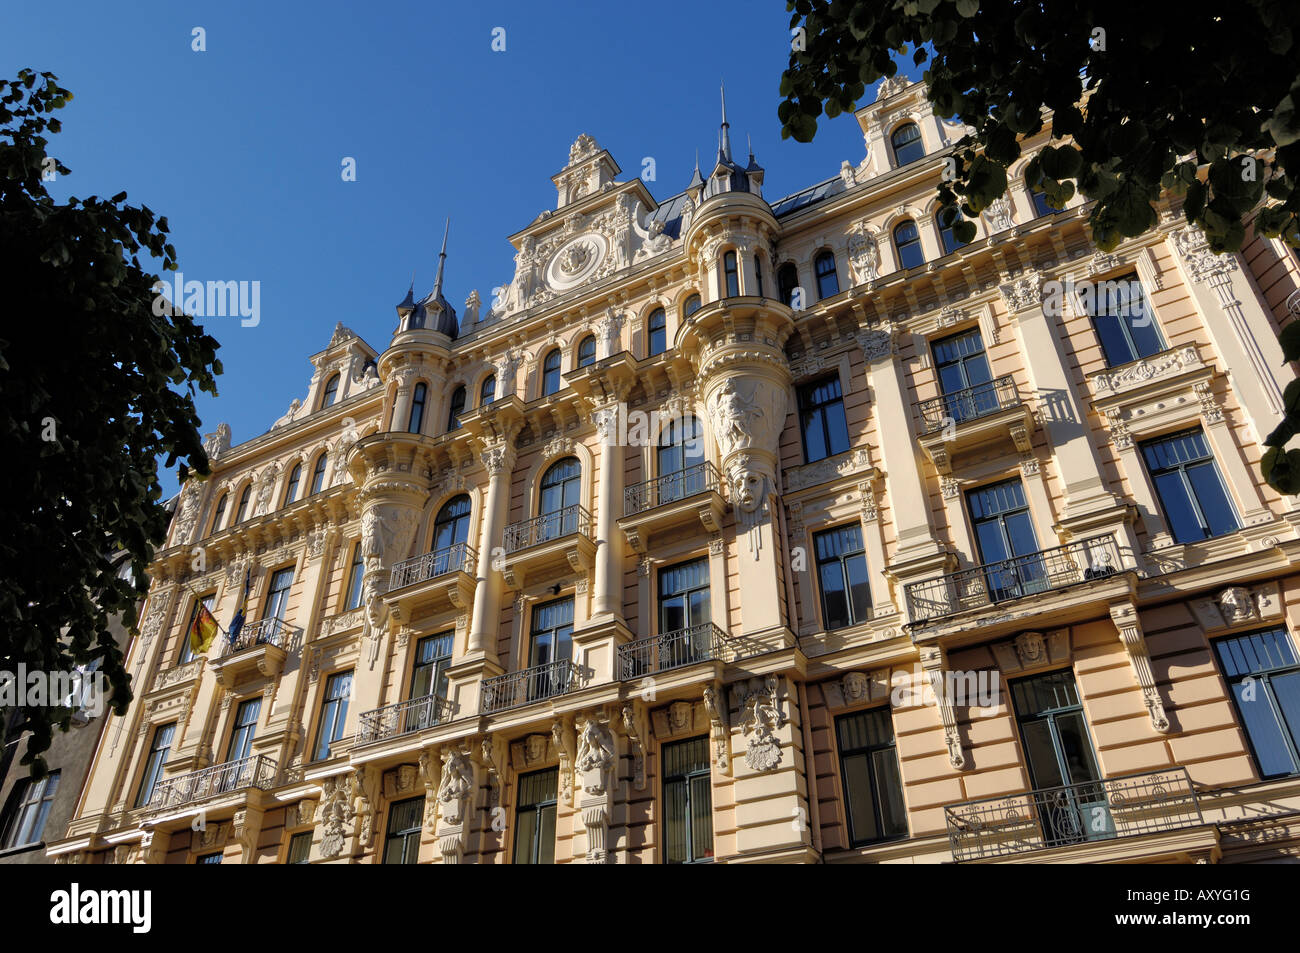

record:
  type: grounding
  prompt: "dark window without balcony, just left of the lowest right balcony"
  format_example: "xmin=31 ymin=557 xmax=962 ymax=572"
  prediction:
xmin=835 ymin=709 xmax=907 ymax=846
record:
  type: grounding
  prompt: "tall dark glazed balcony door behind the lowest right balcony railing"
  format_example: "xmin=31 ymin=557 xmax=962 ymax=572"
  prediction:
xmin=1009 ymin=671 xmax=1115 ymax=848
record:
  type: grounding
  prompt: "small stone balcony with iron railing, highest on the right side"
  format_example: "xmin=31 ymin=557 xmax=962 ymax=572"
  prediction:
xmin=917 ymin=377 xmax=1034 ymax=473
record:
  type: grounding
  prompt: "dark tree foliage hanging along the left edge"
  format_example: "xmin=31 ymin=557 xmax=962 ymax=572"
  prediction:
xmin=0 ymin=70 xmax=221 ymax=775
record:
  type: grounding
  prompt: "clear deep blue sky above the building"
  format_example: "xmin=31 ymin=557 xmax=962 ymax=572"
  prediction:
xmin=0 ymin=0 xmax=909 ymax=491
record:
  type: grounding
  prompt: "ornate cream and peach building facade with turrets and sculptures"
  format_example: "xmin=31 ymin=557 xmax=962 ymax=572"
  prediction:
xmin=48 ymin=81 xmax=1300 ymax=863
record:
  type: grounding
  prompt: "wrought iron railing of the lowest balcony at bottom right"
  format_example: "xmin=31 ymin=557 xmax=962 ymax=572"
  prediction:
xmin=944 ymin=767 xmax=1205 ymax=863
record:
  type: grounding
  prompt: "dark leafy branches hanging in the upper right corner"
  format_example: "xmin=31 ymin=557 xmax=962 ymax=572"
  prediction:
xmin=779 ymin=0 xmax=1300 ymax=493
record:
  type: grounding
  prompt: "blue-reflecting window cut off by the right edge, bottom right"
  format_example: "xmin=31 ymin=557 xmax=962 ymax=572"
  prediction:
xmin=1214 ymin=627 xmax=1300 ymax=779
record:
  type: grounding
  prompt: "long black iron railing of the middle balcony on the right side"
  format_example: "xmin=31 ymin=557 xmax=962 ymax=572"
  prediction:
xmin=906 ymin=536 xmax=1119 ymax=621
